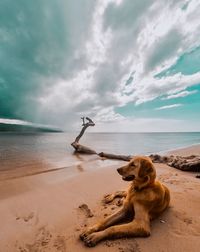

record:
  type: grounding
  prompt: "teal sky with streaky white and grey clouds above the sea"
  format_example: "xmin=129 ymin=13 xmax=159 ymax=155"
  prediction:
xmin=0 ymin=0 xmax=200 ymax=132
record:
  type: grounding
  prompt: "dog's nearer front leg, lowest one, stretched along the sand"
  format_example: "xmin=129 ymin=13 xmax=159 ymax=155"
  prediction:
xmin=84 ymin=220 xmax=150 ymax=247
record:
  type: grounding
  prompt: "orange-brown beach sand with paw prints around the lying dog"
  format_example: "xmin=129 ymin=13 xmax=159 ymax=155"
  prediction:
xmin=0 ymin=146 xmax=200 ymax=252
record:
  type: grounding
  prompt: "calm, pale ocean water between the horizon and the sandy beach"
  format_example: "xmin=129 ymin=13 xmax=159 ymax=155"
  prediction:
xmin=0 ymin=132 xmax=200 ymax=179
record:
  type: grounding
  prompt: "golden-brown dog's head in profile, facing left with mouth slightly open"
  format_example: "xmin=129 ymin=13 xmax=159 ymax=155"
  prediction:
xmin=117 ymin=156 xmax=156 ymax=190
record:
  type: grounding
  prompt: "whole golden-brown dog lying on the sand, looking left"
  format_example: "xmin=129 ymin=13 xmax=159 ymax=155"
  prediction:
xmin=80 ymin=156 xmax=170 ymax=247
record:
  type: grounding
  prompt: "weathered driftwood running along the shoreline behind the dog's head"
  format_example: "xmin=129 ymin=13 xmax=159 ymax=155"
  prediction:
xmin=71 ymin=117 xmax=200 ymax=173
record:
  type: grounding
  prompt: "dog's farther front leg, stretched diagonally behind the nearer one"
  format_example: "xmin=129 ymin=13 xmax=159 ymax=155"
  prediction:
xmin=80 ymin=207 xmax=127 ymax=240
